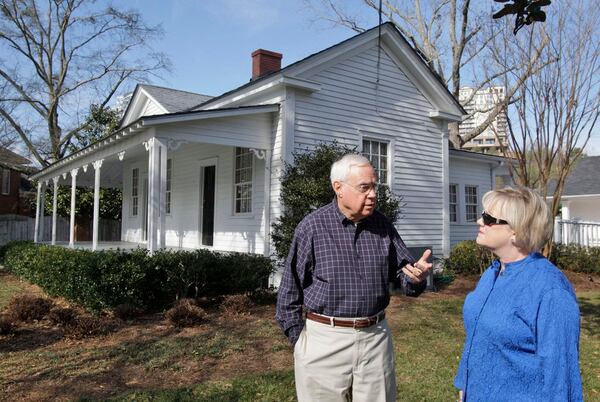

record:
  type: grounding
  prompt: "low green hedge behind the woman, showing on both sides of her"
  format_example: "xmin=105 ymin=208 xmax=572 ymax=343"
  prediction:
xmin=446 ymin=240 xmax=600 ymax=275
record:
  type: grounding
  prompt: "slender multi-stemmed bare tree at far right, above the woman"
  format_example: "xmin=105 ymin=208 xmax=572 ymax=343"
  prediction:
xmin=505 ymin=0 xmax=600 ymax=250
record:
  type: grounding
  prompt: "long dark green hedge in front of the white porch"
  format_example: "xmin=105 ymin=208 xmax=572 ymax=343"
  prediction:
xmin=0 ymin=242 xmax=273 ymax=311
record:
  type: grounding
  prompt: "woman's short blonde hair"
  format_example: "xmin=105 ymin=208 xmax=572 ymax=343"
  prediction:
xmin=483 ymin=187 xmax=552 ymax=252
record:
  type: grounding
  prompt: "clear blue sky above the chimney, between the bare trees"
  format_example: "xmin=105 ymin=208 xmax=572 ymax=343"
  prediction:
xmin=127 ymin=0 xmax=600 ymax=155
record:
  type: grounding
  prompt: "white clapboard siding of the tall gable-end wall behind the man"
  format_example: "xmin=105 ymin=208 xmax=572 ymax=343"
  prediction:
xmin=294 ymin=44 xmax=445 ymax=255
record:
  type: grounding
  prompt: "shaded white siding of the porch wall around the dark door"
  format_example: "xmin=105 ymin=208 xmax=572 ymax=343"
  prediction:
xmin=123 ymin=144 xmax=265 ymax=254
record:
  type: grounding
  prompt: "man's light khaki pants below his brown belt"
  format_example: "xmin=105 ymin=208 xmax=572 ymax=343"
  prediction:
xmin=294 ymin=320 xmax=396 ymax=402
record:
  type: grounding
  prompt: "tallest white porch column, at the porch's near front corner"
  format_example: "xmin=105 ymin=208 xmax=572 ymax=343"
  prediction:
xmin=146 ymin=138 xmax=160 ymax=253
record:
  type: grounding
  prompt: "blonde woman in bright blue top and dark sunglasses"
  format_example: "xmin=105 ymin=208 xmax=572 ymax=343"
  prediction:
xmin=454 ymin=188 xmax=583 ymax=402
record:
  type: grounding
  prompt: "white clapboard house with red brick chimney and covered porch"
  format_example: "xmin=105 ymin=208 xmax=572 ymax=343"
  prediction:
xmin=34 ymin=23 xmax=502 ymax=280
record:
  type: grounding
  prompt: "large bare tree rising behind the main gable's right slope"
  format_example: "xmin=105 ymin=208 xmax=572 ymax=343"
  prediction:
xmin=305 ymin=0 xmax=543 ymax=148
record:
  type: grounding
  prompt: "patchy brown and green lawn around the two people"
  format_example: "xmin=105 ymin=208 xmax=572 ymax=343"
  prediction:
xmin=0 ymin=276 xmax=600 ymax=401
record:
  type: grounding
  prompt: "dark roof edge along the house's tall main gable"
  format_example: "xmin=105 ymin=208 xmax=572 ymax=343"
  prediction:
xmin=190 ymin=21 xmax=467 ymax=115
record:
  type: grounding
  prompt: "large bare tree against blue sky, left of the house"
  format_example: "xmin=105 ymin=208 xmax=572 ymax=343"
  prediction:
xmin=0 ymin=0 xmax=168 ymax=166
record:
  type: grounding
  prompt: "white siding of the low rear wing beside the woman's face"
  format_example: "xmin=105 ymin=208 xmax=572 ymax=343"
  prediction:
xmin=449 ymin=156 xmax=492 ymax=247
